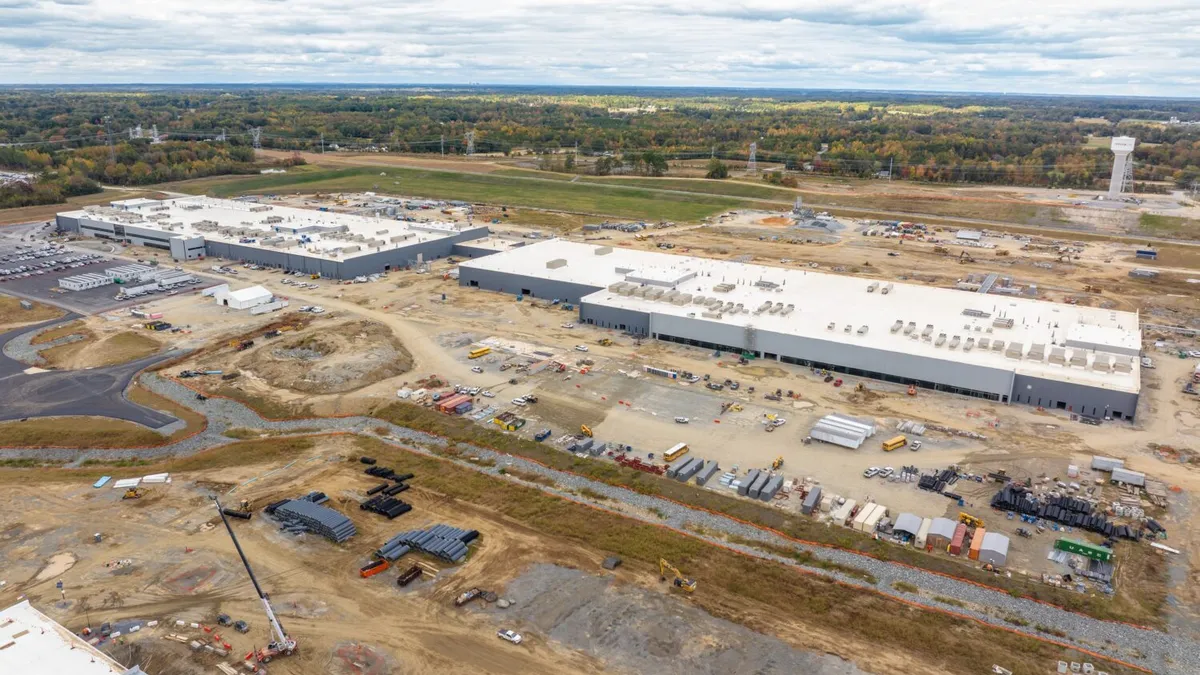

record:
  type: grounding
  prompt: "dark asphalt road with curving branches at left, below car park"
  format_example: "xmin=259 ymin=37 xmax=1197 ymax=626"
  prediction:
xmin=0 ymin=313 xmax=182 ymax=429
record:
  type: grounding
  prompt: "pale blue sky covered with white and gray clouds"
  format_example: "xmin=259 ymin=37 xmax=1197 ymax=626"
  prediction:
xmin=0 ymin=0 xmax=1200 ymax=96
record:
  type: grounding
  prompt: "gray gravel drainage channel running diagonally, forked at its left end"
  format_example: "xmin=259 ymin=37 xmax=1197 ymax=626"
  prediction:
xmin=7 ymin=374 xmax=1200 ymax=675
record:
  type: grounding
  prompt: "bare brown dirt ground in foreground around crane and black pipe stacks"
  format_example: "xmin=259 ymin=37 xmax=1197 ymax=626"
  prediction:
xmin=0 ymin=440 xmax=873 ymax=675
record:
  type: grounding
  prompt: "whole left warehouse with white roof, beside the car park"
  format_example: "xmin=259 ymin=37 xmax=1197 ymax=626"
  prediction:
xmin=58 ymin=197 xmax=487 ymax=279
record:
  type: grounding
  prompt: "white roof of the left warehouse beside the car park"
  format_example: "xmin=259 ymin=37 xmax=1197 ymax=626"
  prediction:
xmin=60 ymin=197 xmax=482 ymax=259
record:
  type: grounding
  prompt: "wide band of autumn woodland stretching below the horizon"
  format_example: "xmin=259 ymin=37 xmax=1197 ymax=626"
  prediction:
xmin=7 ymin=88 xmax=1200 ymax=194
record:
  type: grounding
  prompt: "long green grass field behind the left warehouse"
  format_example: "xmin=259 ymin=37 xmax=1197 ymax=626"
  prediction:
xmin=175 ymin=167 xmax=752 ymax=221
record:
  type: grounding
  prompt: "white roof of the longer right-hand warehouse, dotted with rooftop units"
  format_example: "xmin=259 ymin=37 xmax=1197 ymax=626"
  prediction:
xmin=460 ymin=239 xmax=1140 ymax=393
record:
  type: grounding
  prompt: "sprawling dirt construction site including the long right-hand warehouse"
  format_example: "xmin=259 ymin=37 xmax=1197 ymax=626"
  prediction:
xmin=0 ymin=186 xmax=1200 ymax=675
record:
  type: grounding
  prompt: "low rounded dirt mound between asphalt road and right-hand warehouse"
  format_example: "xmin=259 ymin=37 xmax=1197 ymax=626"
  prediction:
xmin=238 ymin=321 xmax=413 ymax=394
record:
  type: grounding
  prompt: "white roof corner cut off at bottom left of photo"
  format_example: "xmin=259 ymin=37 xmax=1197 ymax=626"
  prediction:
xmin=0 ymin=601 xmax=142 ymax=675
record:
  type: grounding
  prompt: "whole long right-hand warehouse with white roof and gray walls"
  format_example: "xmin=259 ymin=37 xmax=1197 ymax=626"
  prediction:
xmin=458 ymin=240 xmax=1141 ymax=419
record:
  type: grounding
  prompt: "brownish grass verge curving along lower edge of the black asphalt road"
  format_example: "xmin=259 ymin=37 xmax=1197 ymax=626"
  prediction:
xmin=0 ymin=387 xmax=204 ymax=448
